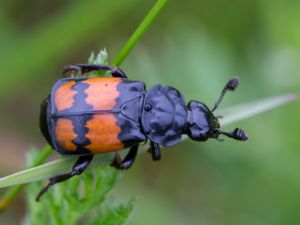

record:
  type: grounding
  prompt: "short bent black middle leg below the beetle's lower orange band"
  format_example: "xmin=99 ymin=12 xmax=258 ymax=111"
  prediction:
xmin=111 ymin=145 xmax=139 ymax=170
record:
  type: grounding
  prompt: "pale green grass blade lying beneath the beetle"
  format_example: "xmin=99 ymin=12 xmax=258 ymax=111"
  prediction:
xmin=0 ymin=94 xmax=298 ymax=188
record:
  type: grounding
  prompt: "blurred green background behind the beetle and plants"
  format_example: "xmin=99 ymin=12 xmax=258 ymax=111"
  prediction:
xmin=0 ymin=0 xmax=300 ymax=225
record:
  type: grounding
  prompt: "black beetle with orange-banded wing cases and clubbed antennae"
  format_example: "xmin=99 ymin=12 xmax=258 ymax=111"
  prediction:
xmin=37 ymin=64 xmax=248 ymax=201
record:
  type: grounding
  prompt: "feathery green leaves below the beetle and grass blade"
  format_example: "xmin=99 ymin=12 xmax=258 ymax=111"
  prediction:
xmin=24 ymin=150 xmax=134 ymax=225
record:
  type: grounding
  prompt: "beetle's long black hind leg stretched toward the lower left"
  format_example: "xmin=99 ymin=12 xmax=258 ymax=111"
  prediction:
xmin=36 ymin=155 xmax=93 ymax=201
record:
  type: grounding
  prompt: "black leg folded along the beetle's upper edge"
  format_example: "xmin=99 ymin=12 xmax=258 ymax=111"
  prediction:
xmin=63 ymin=64 xmax=127 ymax=78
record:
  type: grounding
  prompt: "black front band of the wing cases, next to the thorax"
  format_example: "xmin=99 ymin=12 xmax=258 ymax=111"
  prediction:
xmin=113 ymin=79 xmax=146 ymax=147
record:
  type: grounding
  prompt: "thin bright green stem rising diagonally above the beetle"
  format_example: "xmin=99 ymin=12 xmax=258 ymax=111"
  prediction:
xmin=112 ymin=0 xmax=168 ymax=66
